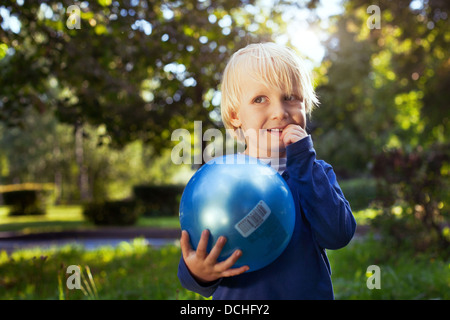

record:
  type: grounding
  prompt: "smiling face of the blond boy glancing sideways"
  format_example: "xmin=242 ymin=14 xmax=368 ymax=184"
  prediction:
xmin=231 ymin=75 xmax=306 ymax=157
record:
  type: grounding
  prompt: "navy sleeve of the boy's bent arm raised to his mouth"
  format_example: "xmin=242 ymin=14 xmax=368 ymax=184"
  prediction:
xmin=286 ymin=136 xmax=356 ymax=249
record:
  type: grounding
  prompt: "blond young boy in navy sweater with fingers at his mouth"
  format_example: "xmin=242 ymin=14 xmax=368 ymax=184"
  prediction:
xmin=178 ymin=43 xmax=356 ymax=300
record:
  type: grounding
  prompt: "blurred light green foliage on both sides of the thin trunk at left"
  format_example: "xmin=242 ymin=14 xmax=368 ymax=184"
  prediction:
xmin=0 ymin=111 xmax=192 ymax=204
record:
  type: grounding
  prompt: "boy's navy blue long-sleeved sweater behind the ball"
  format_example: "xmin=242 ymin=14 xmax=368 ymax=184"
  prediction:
xmin=178 ymin=136 xmax=356 ymax=300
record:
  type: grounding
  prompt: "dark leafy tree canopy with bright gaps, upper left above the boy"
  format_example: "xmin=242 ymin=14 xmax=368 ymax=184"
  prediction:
xmin=0 ymin=0 xmax=282 ymax=152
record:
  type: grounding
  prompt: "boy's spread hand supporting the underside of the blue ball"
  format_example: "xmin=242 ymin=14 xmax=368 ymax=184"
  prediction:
xmin=180 ymin=230 xmax=249 ymax=283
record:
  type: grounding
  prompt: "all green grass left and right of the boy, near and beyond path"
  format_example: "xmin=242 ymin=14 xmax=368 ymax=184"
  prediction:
xmin=0 ymin=207 xmax=450 ymax=300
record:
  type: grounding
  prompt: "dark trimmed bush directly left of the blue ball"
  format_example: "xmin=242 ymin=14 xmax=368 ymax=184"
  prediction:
xmin=133 ymin=185 xmax=184 ymax=217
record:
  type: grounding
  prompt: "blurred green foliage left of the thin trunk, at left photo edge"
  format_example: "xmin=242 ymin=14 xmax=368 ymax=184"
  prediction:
xmin=0 ymin=110 xmax=76 ymax=199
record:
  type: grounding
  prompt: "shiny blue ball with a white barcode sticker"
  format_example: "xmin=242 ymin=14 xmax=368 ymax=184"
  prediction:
xmin=180 ymin=154 xmax=295 ymax=272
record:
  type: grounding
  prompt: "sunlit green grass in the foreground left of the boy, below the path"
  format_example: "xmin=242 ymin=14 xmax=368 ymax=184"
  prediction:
xmin=0 ymin=239 xmax=202 ymax=300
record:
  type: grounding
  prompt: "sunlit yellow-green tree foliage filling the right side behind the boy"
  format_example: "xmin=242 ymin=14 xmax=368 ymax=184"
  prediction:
xmin=312 ymin=0 xmax=450 ymax=254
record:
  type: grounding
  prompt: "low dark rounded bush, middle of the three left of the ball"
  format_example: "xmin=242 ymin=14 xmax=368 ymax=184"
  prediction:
xmin=83 ymin=200 xmax=141 ymax=226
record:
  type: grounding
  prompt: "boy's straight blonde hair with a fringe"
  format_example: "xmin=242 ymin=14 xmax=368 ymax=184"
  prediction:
xmin=221 ymin=42 xmax=319 ymax=130
